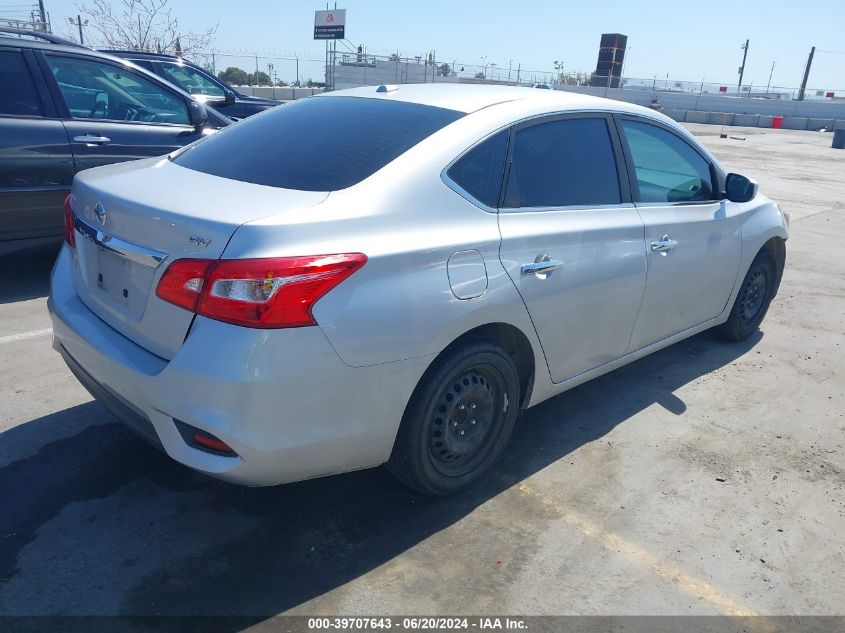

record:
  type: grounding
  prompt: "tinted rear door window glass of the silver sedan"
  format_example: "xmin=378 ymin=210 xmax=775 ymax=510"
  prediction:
xmin=505 ymin=118 xmax=622 ymax=207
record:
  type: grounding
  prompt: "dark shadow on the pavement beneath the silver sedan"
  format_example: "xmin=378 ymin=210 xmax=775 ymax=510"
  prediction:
xmin=0 ymin=333 xmax=761 ymax=622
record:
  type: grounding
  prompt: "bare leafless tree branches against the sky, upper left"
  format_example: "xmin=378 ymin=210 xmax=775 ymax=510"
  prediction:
xmin=77 ymin=0 xmax=217 ymax=56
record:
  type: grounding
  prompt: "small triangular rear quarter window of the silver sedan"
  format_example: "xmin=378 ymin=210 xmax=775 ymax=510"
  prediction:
xmin=448 ymin=130 xmax=508 ymax=207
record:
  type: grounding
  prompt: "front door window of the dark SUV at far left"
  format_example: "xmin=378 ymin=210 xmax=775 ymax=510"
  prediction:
xmin=47 ymin=55 xmax=190 ymax=125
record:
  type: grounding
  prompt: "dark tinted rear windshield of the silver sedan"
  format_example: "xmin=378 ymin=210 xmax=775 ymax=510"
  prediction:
xmin=173 ymin=97 xmax=463 ymax=191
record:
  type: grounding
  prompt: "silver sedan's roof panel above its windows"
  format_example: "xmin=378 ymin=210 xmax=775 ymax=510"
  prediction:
xmin=318 ymin=83 xmax=653 ymax=114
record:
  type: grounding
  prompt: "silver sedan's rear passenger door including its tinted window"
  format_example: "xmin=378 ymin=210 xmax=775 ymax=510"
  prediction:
xmin=499 ymin=113 xmax=646 ymax=382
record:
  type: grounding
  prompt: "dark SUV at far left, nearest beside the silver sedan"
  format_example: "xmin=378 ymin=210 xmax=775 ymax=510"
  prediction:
xmin=0 ymin=28 xmax=232 ymax=255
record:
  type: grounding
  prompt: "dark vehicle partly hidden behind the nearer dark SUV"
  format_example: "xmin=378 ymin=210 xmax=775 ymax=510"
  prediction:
xmin=102 ymin=49 xmax=281 ymax=119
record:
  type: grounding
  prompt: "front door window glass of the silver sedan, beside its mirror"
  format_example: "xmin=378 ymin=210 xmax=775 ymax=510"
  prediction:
xmin=622 ymin=119 xmax=716 ymax=202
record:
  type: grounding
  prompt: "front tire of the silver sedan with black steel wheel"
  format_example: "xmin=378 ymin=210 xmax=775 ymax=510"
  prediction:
xmin=717 ymin=249 xmax=778 ymax=342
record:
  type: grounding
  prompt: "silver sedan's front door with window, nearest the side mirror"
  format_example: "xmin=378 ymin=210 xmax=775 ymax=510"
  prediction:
xmin=619 ymin=116 xmax=742 ymax=351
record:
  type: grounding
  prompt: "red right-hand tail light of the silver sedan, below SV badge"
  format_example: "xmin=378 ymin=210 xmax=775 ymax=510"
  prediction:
xmin=156 ymin=253 xmax=367 ymax=328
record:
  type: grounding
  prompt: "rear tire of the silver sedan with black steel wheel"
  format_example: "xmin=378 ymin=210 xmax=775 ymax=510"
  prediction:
xmin=387 ymin=342 xmax=520 ymax=496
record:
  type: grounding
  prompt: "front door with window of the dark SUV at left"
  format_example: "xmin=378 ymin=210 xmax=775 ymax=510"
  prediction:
xmin=36 ymin=53 xmax=208 ymax=171
